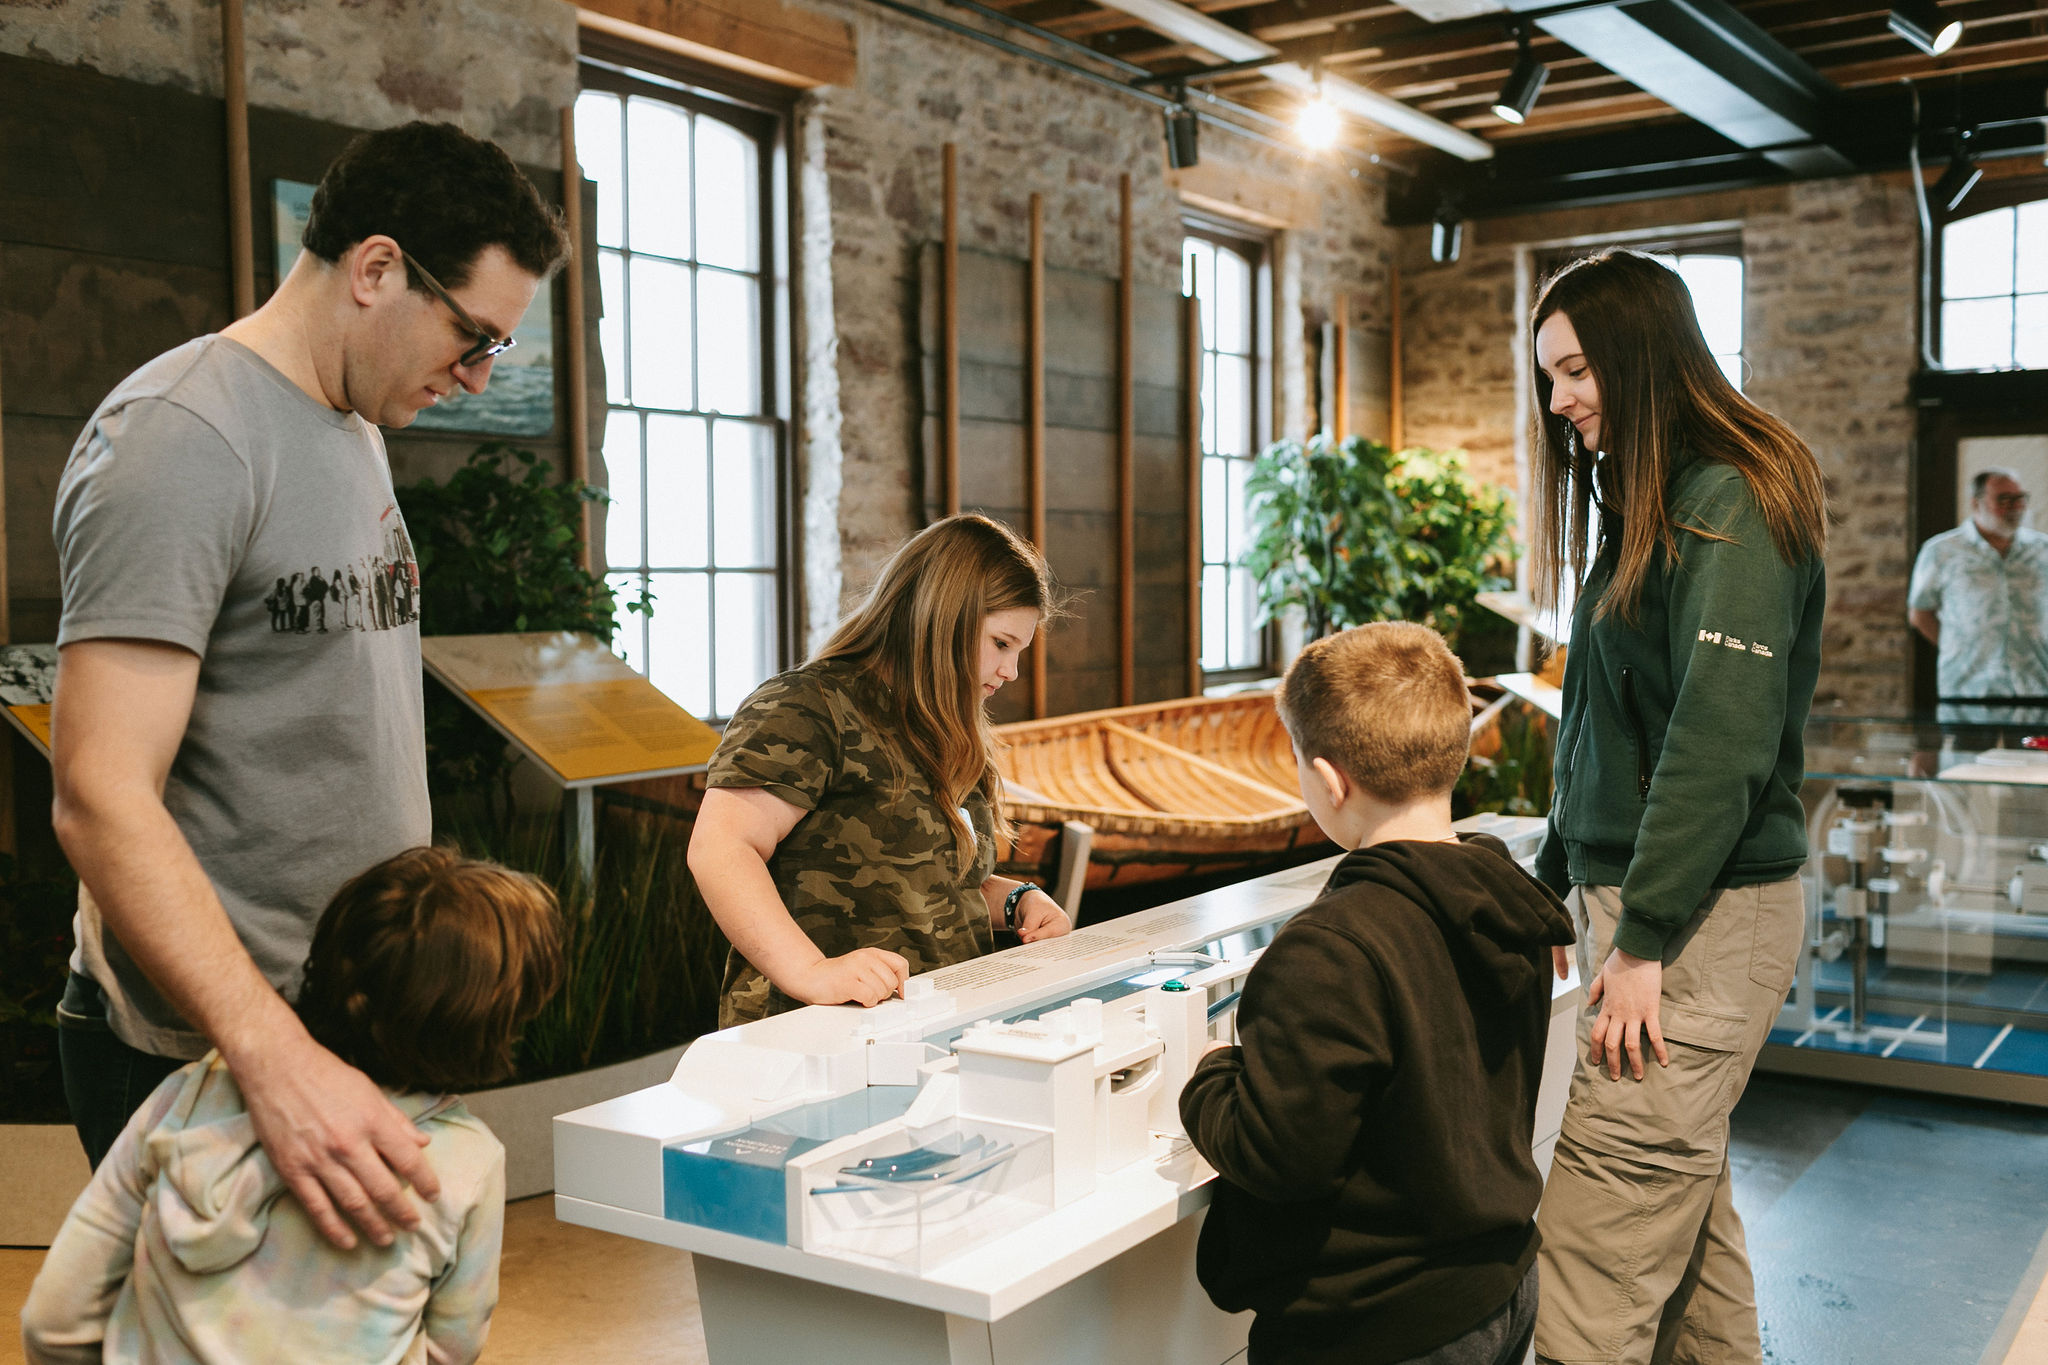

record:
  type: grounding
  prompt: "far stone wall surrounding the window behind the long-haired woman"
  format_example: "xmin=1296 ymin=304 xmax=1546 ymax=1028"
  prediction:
xmin=1403 ymin=176 xmax=1917 ymax=714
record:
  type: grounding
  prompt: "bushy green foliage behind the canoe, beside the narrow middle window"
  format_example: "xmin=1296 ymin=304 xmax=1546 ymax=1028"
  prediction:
xmin=1245 ymin=436 xmax=1516 ymax=647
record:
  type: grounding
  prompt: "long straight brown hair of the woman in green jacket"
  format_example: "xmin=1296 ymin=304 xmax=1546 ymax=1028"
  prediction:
xmin=1530 ymin=250 xmax=1827 ymax=624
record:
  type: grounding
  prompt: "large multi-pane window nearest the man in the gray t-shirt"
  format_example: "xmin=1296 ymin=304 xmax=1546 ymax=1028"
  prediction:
xmin=575 ymin=65 xmax=784 ymax=718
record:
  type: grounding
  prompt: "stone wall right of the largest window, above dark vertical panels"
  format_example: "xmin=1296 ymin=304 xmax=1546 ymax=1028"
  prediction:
xmin=799 ymin=0 xmax=1393 ymax=609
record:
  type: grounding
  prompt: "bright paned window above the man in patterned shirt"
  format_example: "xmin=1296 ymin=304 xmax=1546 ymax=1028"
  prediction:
xmin=1939 ymin=201 xmax=2048 ymax=370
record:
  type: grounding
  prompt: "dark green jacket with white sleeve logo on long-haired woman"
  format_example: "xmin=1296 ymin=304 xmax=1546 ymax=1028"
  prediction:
xmin=1536 ymin=460 xmax=1827 ymax=958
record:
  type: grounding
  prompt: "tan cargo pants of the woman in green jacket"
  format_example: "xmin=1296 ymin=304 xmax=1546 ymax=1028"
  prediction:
xmin=1536 ymin=878 xmax=1806 ymax=1365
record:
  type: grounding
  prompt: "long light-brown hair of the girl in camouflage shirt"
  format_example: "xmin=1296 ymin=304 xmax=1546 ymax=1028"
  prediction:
xmin=811 ymin=514 xmax=1059 ymax=853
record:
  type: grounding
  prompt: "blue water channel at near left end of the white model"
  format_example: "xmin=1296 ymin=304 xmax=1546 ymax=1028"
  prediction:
xmin=662 ymin=1085 xmax=918 ymax=1244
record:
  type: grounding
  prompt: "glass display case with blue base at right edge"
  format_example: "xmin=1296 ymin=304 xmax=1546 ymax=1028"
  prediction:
xmin=1759 ymin=708 xmax=2048 ymax=1105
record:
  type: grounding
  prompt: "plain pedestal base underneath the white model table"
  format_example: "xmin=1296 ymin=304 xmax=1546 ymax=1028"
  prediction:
xmin=694 ymin=1209 xmax=1251 ymax=1365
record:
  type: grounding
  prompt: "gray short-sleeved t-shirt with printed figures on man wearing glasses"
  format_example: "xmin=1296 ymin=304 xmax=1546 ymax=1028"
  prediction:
xmin=55 ymin=336 xmax=432 ymax=1058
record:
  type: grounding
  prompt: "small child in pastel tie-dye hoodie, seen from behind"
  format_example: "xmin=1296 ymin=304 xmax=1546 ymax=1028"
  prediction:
xmin=23 ymin=849 xmax=561 ymax=1365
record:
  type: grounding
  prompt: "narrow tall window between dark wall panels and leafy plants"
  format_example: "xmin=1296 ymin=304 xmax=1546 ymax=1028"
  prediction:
xmin=1182 ymin=231 xmax=1266 ymax=675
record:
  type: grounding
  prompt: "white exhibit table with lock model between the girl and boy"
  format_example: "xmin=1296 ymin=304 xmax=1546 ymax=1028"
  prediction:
xmin=555 ymin=817 xmax=1581 ymax=1365
